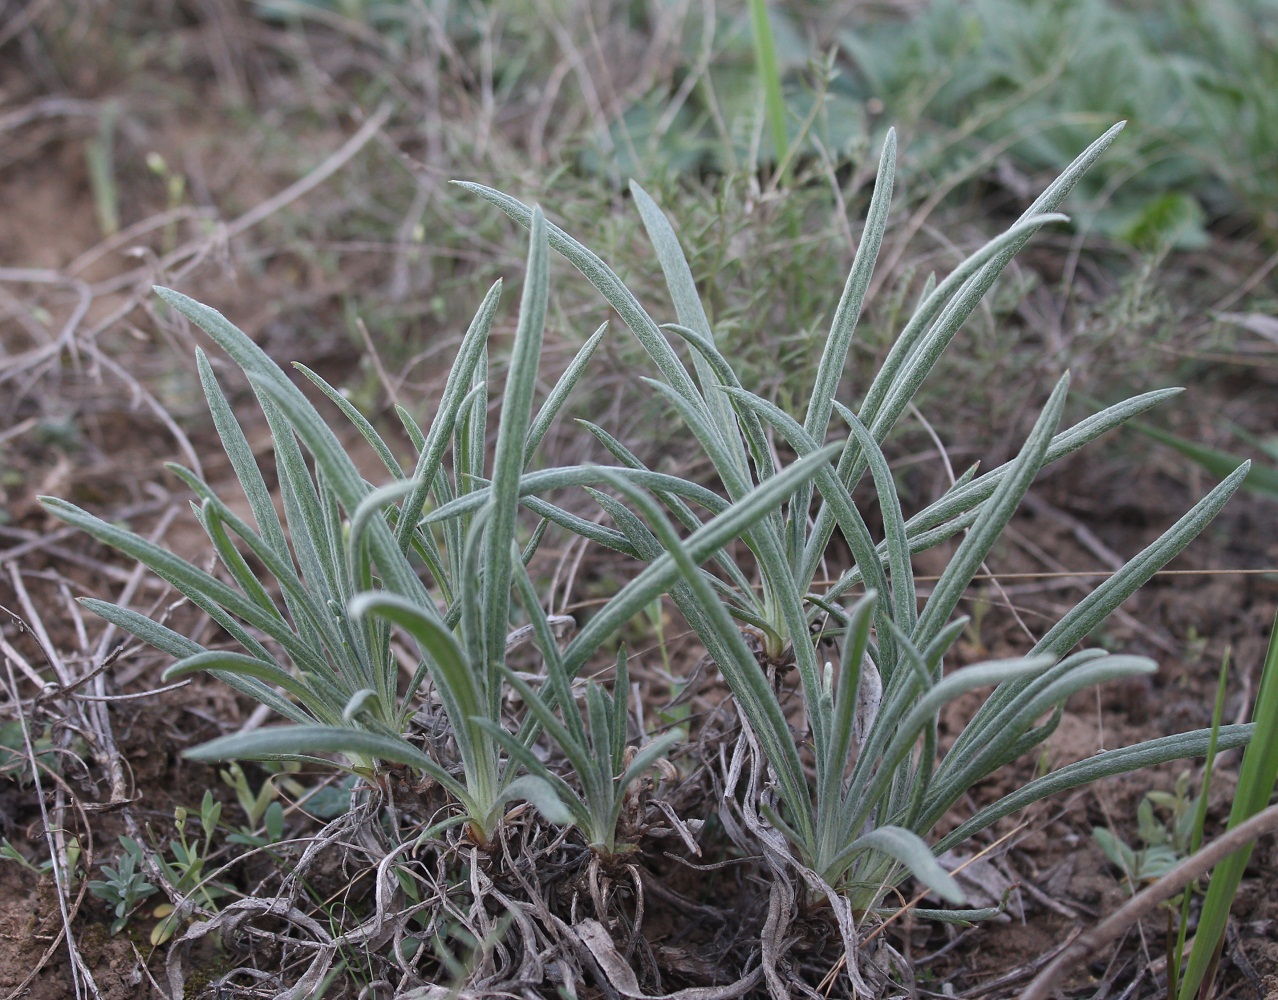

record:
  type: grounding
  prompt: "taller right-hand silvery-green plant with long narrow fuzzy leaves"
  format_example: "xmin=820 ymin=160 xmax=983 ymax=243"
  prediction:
xmin=444 ymin=125 xmax=1250 ymax=909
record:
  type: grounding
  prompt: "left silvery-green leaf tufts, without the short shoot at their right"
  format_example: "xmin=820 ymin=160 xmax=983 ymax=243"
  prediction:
xmin=45 ymin=210 xmax=585 ymax=839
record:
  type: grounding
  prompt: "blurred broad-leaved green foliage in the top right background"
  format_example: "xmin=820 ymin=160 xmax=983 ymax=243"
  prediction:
xmin=840 ymin=0 xmax=1278 ymax=242
